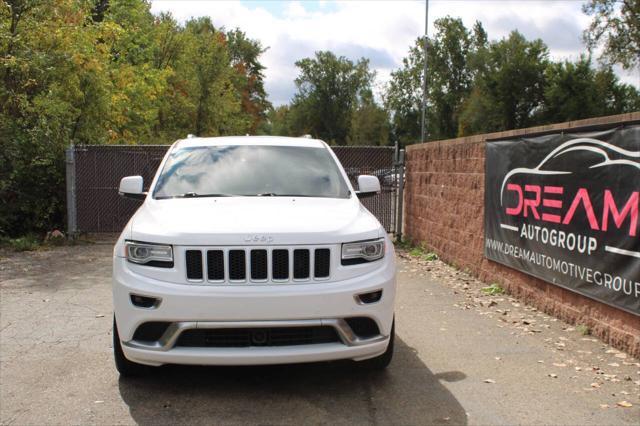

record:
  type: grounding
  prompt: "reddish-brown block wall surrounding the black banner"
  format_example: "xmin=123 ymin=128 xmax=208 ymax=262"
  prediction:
xmin=404 ymin=112 xmax=640 ymax=357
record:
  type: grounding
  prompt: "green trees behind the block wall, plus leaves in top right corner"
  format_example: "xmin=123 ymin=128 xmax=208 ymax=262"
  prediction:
xmin=384 ymin=16 xmax=640 ymax=144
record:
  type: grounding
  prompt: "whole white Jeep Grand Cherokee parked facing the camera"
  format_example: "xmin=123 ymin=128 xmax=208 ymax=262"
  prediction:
xmin=113 ymin=136 xmax=396 ymax=375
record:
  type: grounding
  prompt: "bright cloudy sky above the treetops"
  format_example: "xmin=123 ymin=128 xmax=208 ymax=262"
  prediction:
xmin=151 ymin=0 xmax=640 ymax=106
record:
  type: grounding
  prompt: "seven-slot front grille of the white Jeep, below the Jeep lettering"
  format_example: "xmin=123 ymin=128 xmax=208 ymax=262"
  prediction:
xmin=185 ymin=248 xmax=331 ymax=282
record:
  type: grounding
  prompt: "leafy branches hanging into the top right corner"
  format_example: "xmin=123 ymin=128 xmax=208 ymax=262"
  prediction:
xmin=582 ymin=0 xmax=640 ymax=69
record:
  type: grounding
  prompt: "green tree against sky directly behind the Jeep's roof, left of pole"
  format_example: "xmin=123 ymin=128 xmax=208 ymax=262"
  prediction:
xmin=291 ymin=51 xmax=374 ymax=145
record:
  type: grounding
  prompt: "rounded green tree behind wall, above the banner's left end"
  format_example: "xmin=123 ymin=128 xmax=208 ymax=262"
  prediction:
xmin=459 ymin=31 xmax=548 ymax=135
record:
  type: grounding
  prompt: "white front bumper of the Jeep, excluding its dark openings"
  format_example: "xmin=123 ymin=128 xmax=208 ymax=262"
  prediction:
xmin=113 ymin=256 xmax=395 ymax=365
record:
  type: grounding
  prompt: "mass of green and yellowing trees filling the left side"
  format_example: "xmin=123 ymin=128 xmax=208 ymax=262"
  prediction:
xmin=0 ymin=0 xmax=270 ymax=236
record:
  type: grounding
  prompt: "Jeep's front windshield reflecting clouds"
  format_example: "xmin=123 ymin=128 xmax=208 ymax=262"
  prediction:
xmin=153 ymin=145 xmax=349 ymax=199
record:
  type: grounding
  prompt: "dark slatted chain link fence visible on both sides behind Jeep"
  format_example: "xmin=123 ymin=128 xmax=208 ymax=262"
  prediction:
xmin=67 ymin=145 xmax=403 ymax=234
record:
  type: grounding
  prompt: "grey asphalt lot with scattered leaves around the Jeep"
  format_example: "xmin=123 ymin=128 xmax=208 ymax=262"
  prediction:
xmin=0 ymin=243 xmax=640 ymax=425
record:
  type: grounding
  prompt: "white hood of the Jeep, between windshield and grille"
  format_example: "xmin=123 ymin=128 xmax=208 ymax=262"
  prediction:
xmin=130 ymin=197 xmax=384 ymax=246
